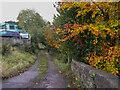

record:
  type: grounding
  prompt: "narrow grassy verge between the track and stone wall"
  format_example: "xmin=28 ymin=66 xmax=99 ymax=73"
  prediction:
xmin=53 ymin=56 xmax=80 ymax=89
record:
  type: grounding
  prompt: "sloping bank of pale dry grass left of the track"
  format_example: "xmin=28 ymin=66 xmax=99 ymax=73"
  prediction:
xmin=0 ymin=49 xmax=37 ymax=79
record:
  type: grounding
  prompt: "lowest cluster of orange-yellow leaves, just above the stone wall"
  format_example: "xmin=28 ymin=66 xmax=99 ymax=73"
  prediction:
xmin=86 ymin=46 xmax=120 ymax=75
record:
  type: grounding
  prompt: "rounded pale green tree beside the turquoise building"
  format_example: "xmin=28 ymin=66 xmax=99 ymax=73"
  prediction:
xmin=17 ymin=9 xmax=46 ymax=53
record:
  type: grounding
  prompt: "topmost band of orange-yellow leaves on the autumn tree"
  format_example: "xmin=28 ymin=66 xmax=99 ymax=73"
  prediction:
xmin=60 ymin=2 xmax=118 ymax=21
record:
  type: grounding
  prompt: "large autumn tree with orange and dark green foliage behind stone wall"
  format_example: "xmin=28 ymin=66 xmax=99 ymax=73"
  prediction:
xmin=44 ymin=2 xmax=120 ymax=75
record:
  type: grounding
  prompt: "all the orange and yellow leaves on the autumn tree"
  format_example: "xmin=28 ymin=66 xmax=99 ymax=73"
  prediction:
xmin=48 ymin=2 xmax=120 ymax=73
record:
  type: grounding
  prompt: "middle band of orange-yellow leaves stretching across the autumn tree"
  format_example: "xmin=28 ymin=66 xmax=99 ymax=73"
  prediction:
xmin=56 ymin=23 xmax=118 ymax=44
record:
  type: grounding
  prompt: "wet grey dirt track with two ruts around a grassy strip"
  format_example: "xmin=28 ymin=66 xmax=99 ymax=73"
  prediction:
xmin=2 ymin=52 xmax=73 ymax=88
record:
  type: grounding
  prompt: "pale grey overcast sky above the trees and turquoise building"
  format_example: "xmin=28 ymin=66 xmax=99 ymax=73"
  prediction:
xmin=0 ymin=0 xmax=60 ymax=22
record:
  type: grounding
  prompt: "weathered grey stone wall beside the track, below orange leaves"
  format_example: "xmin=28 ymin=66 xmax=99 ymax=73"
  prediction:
xmin=71 ymin=60 xmax=120 ymax=88
